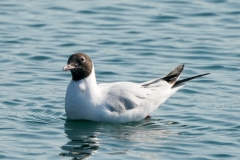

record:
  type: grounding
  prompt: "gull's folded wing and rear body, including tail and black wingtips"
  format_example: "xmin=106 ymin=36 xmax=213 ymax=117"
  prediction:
xmin=96 ymin=65 xmax=200 ymax=119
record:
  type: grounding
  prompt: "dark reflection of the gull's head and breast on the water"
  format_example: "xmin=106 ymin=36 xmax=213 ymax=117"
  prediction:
xmin=60 ymin=120 xmax=101 ymax=159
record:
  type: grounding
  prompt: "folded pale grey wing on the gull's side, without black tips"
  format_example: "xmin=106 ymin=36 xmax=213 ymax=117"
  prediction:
xmin=99 ymin=82 xmax=152 ymax=113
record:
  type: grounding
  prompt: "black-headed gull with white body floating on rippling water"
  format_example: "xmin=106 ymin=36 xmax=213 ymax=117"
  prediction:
xmin=63 ymin=53 xmax=209 ymax=123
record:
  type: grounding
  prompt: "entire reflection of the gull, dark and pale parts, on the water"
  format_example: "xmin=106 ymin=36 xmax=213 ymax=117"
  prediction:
xmin=60 ymin=119 xmax=176 ymax=160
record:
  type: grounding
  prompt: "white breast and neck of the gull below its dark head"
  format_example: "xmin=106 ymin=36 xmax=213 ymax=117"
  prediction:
xmin=65 ymin=66 xmax=102 ymax=120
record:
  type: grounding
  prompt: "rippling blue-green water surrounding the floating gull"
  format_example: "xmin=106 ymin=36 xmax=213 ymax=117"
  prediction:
xmin=0 ymin=0 xmax=240 ymax=160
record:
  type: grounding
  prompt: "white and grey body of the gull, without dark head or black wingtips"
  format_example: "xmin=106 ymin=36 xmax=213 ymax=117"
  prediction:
xmin=65 ymin=67 xmax=183 ymax=123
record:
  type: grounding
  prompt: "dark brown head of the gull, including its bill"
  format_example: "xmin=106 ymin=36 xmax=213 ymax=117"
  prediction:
xmin=63 ymin=53 xmax=93 ymax=81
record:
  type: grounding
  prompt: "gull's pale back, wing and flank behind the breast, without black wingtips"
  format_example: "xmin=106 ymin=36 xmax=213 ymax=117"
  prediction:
xmin=99 ymin=80 xmax=179 ymax=123
